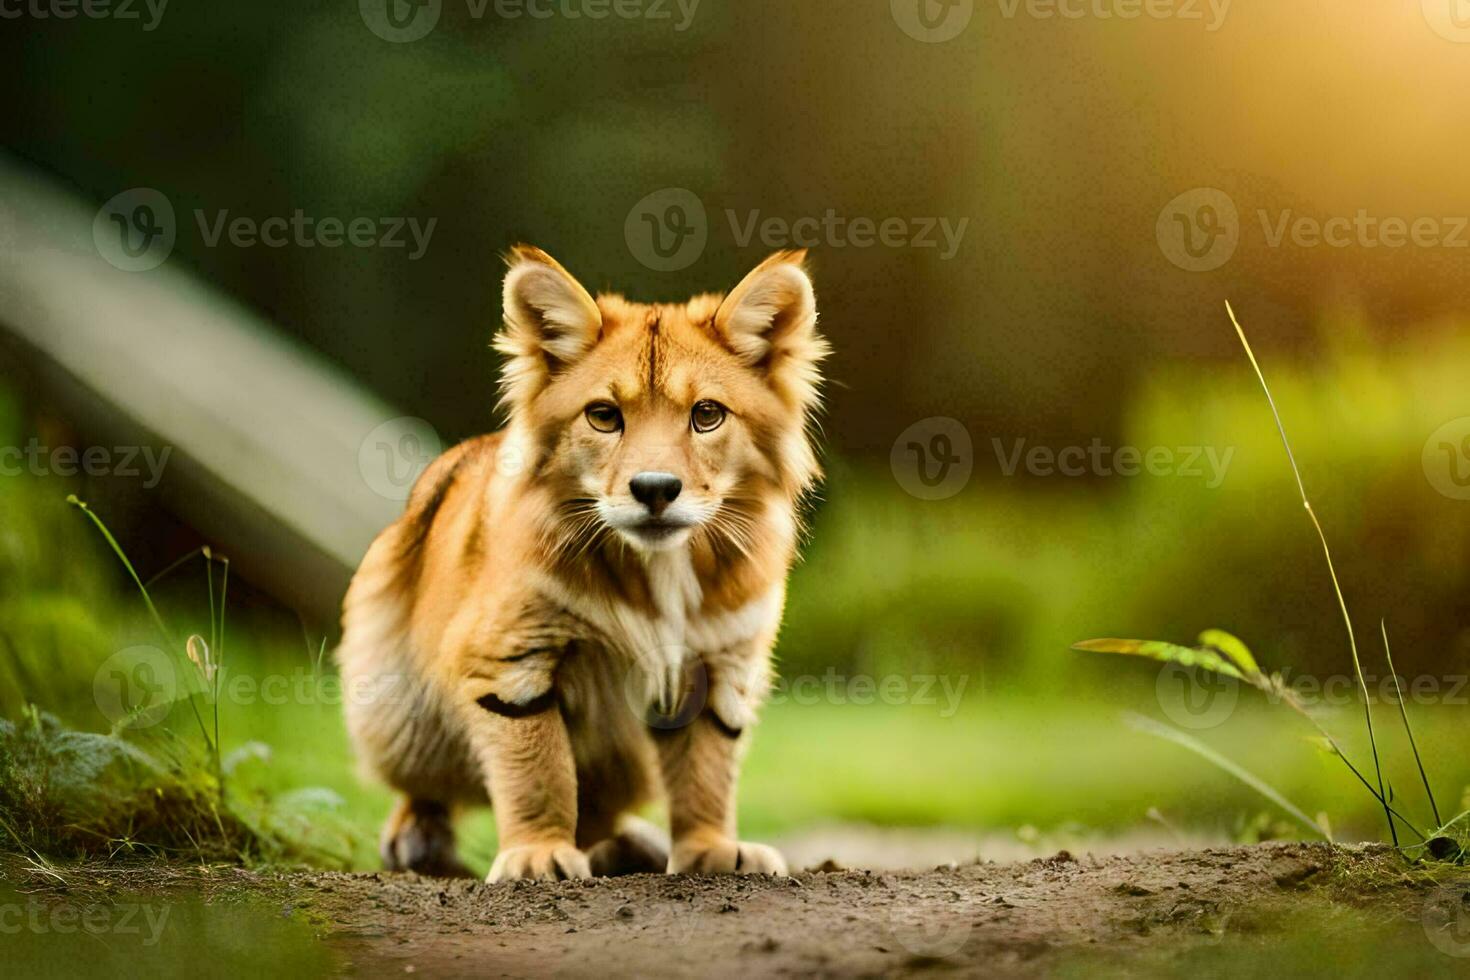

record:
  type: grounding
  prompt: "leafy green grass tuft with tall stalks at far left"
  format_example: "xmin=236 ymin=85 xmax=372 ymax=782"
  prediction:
xmin=0 ymin=495 xmax=354 ymax=867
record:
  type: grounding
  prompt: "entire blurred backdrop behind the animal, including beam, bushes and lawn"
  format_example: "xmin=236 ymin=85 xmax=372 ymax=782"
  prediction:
xmin=0 ymin=0 xmax=1470 ymax=864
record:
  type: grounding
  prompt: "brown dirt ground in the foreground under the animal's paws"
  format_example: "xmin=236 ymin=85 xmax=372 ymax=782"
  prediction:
xmin=2 ymin=845 xmax=1470 ymax=980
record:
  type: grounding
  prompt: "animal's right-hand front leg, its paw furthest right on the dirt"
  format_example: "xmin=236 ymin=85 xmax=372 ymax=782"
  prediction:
xmin=650 ymin=649 xmax=786 ymax=874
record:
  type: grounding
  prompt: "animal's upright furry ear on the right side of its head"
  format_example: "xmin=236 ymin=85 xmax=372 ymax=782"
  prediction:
xmin=714 ymin=251 xmax=828 ymax=410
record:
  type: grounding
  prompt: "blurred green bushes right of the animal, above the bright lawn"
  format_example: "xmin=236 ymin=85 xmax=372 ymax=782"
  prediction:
xmin=781 ymin=320 xmax=1470 ymax=685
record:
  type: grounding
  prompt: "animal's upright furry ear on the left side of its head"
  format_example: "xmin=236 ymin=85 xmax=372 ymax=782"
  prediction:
xmin=495 ymin=245 xmax=603 ymax=406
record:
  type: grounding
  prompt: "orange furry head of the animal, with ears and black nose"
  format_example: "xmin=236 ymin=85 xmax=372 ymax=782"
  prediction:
xmin=495 ymin=245 xmax=828 ymax=551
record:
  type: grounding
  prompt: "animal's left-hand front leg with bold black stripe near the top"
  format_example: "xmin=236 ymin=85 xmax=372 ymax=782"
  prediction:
xmin=465 ymin=651 xmax=591 ymax=882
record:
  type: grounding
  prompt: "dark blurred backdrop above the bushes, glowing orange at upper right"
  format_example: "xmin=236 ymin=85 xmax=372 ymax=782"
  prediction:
xmin=0 ymin=0 xmax=1470 ymax=458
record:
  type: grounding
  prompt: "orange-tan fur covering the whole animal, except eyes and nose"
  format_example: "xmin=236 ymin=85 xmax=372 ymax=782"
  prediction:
xmin=338 ymin=247 xmax=826 ymax=880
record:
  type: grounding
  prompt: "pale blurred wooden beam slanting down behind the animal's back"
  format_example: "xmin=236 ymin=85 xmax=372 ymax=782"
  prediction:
xmin=0 ymin=156 xmax=438 ymax=621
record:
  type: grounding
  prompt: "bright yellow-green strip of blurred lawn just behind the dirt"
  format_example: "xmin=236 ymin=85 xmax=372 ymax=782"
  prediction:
xmin=214 ymin=681 xmax=1470 ymax=867
